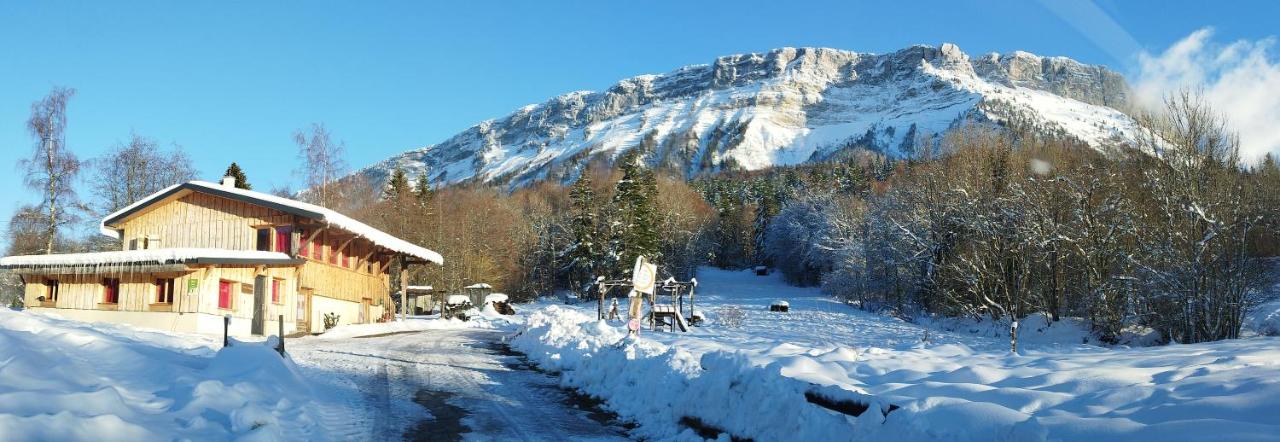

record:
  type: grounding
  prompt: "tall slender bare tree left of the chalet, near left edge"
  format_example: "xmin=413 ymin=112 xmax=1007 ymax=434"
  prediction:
xmin=18 ymin=87 xmax=83 ymax=254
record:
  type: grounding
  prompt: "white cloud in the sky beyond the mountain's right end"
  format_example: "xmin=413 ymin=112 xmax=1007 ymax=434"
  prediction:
xmin=1134 ymin=28 xmax=1280 ymax=163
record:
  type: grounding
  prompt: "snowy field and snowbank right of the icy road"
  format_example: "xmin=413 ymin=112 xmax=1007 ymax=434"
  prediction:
xmin=513 ymin=269 xmax=1280 ymax=441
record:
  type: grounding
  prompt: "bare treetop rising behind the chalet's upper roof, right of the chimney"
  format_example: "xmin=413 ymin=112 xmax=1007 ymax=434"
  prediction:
xmin=293 ymin=123 xmax=347 ymax=208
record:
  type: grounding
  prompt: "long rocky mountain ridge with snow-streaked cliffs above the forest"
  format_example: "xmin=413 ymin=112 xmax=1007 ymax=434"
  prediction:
xmin=357 ymin=44 xmax=1137 ymax=186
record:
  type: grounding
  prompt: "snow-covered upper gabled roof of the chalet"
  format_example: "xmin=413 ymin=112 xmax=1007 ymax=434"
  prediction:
xmin=100 ymin=181 xmax=444 ymax=265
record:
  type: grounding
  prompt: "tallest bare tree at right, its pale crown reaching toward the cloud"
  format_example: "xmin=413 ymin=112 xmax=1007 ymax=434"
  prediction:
xmin=1137 ymin=91 xmax=1262 ymax=343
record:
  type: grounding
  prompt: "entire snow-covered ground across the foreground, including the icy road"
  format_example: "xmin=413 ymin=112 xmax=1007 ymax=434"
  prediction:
xmin=0 ymin=269 xmax=1280 ymax=442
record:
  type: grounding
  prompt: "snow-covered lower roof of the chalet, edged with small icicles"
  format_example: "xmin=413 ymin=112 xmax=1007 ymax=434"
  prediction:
xmin=0 ymin=249 xmax=294 ymax=268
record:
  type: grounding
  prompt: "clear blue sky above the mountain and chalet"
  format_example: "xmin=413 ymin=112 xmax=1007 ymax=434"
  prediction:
xmin=0 ymin=1 xmax=1280 ymax=240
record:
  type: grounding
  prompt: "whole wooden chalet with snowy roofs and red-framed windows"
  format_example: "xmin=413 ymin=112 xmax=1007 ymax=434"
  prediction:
xmin=0 ymin=178 xmax=443 ymax=336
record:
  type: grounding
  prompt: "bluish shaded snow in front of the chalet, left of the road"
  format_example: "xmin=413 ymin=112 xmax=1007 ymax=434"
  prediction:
xmin=0 ymin=309 xmax=324 ymax=441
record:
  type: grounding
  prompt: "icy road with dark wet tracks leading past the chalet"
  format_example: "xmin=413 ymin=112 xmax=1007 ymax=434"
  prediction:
xmin=288 ymin=320 xmax=626 ymax=441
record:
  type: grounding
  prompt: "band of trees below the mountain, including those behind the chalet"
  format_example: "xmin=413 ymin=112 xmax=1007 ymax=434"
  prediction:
xmin=5 ymin=88 xmax=1280 ymax=342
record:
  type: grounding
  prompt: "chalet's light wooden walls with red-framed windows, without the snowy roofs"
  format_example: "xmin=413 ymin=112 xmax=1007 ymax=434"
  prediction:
xmin=5 ymin=179 xmax=438 ymax=332
